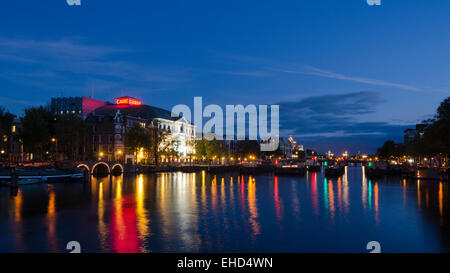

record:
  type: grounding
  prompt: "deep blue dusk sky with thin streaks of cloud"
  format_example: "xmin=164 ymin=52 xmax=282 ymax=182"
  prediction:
xmin=0 ymin=0 xmax=450 ymax=153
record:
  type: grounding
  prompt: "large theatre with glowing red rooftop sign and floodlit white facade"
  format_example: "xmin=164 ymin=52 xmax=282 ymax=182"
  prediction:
xmin=86 ymin=97 xmax=195 ymax=163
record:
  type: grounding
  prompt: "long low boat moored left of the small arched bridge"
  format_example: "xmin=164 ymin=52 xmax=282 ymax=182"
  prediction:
xmin=0 ymin=168 xmax=84 ymax=185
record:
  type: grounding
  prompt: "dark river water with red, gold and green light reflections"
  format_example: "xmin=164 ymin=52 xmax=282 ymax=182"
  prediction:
xmin=0 ymin=167 xmax=450 ymax=252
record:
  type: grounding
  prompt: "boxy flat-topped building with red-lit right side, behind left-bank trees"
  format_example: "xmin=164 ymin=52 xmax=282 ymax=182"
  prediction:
xmin=50 ymin=97 xmax=108 ymax=117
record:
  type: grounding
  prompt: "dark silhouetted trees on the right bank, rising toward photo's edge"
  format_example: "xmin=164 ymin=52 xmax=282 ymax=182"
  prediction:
xmin=377 ymin=97 xmax=450 ymax=162
